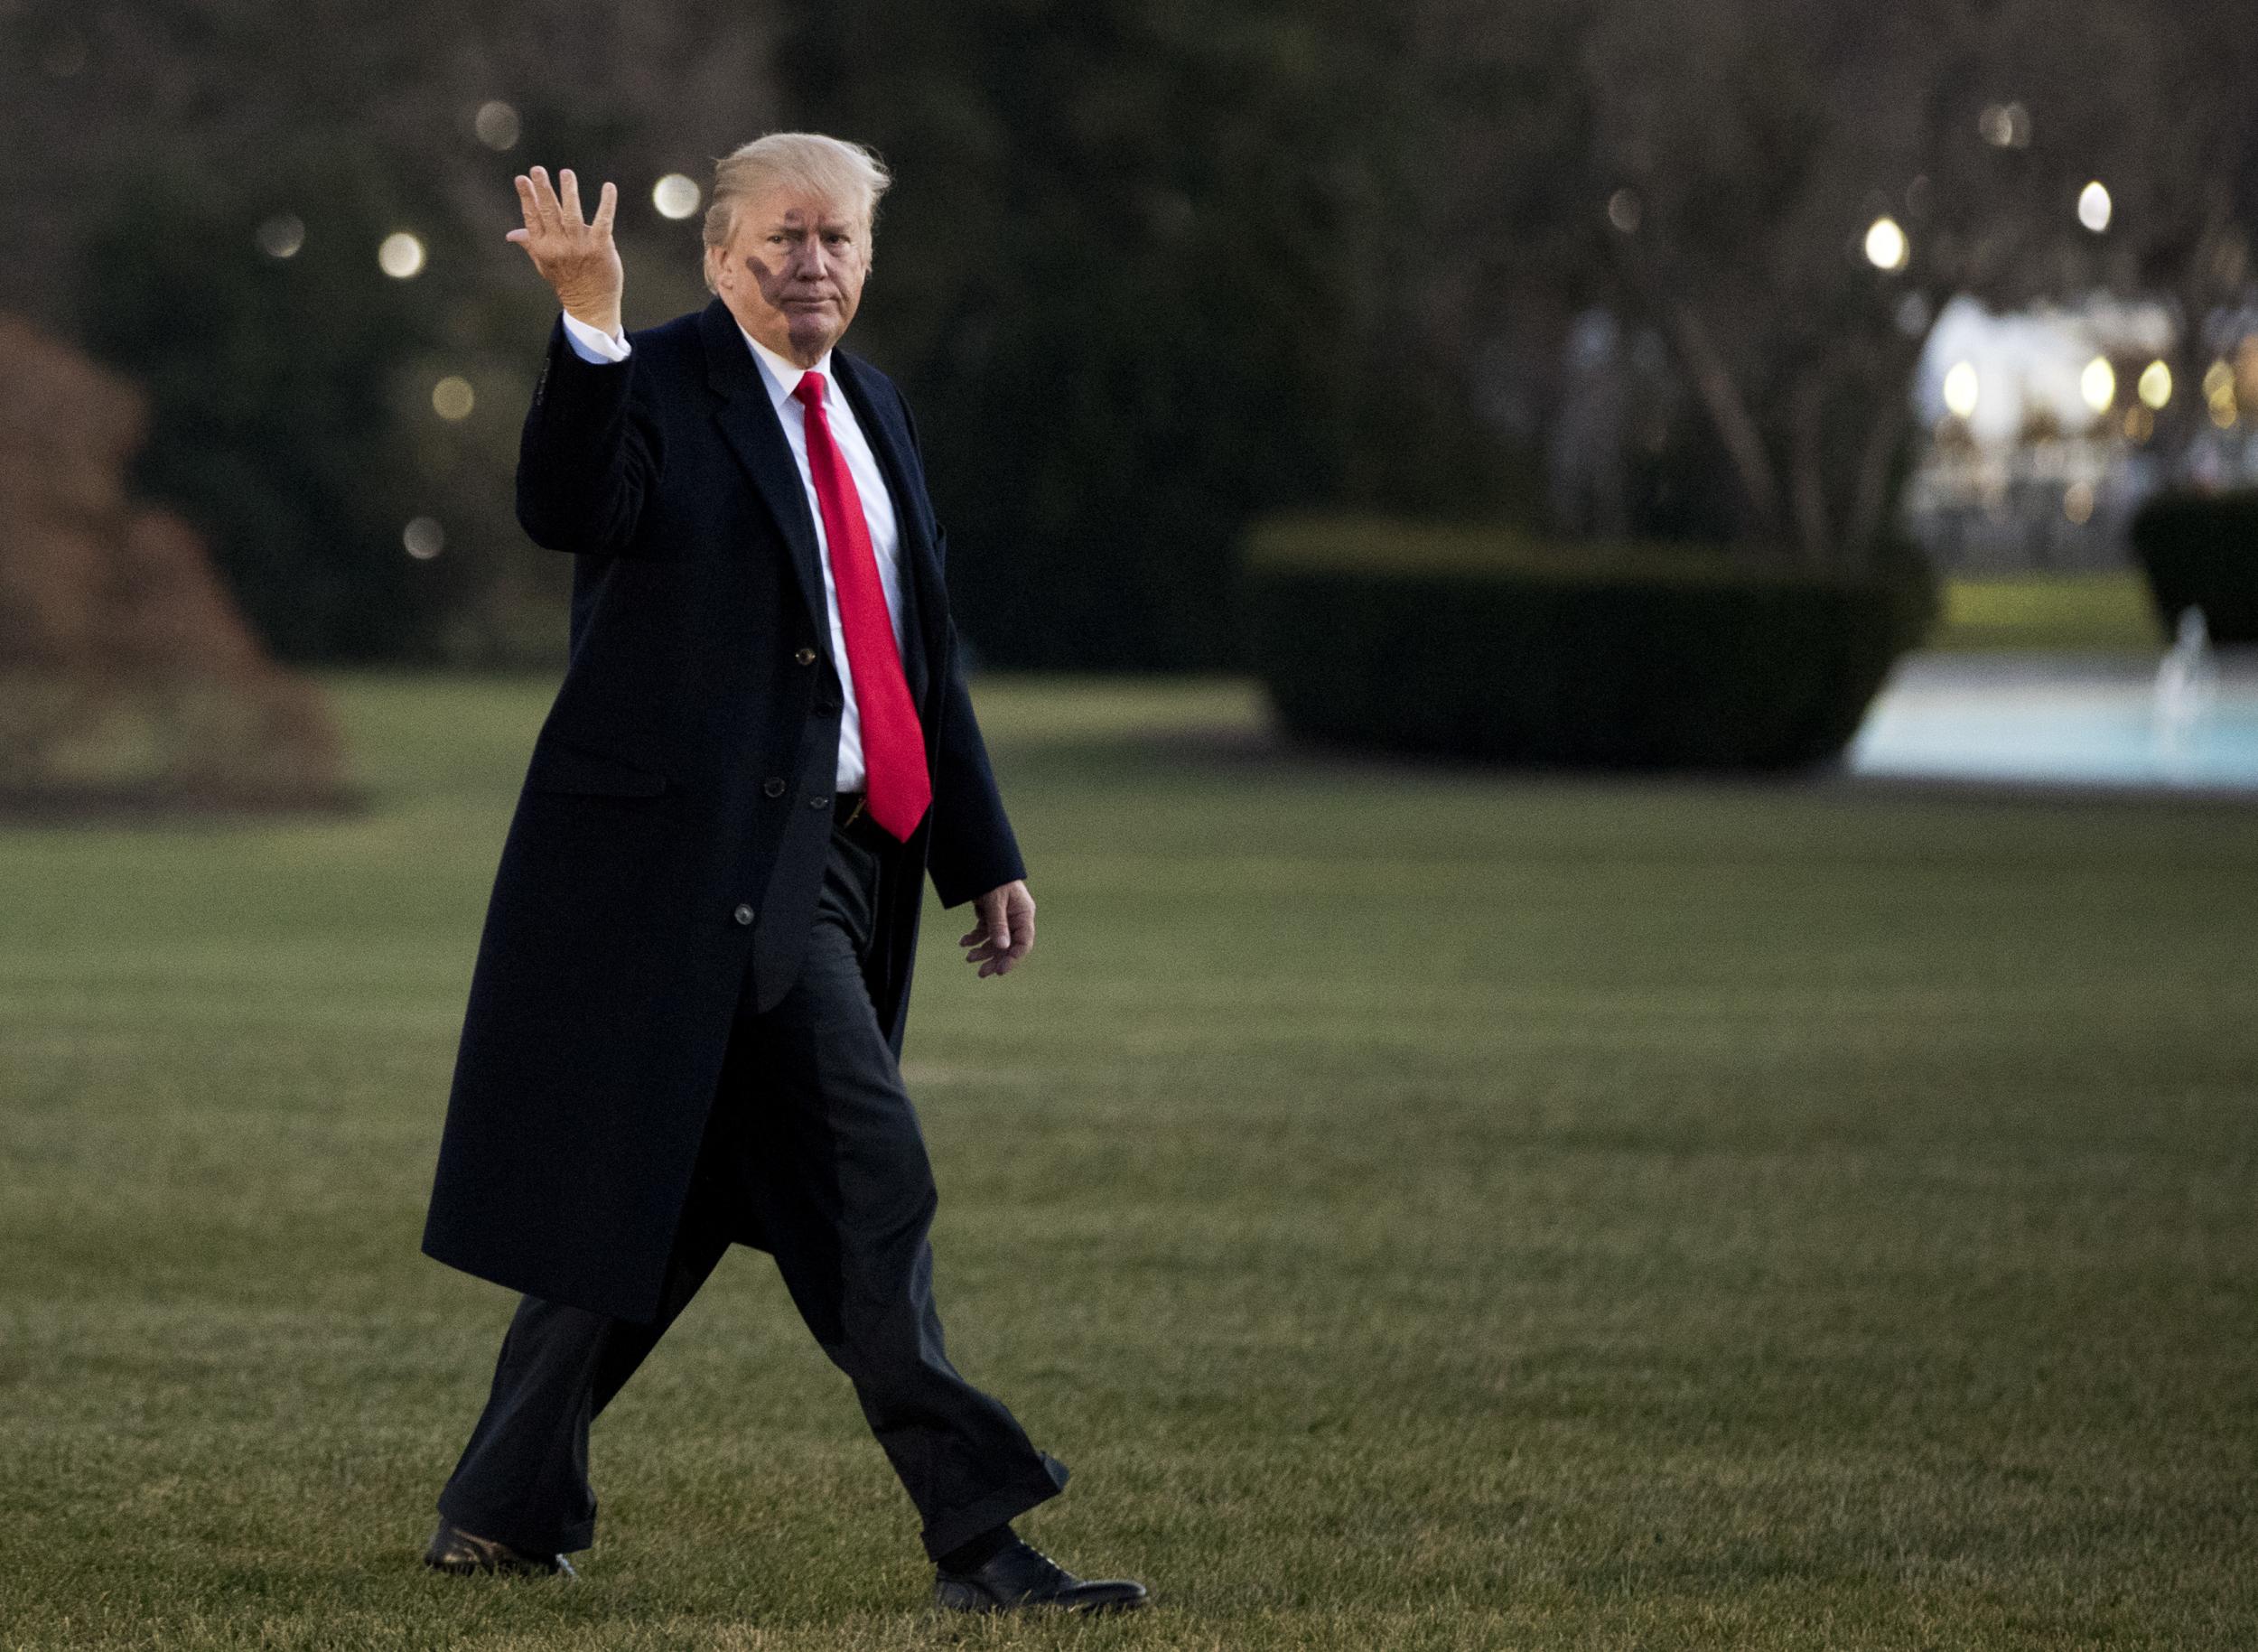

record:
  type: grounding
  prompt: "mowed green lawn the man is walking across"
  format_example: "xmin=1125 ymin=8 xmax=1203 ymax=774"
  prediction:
xmin=0 ymin=679 xmax=2258 ymax=1652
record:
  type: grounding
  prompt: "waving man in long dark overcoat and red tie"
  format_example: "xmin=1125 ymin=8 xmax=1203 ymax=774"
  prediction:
xmin=425 ymin=133 xmax=1145 ymax=1611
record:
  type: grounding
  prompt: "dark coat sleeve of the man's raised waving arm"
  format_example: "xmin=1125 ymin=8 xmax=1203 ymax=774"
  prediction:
xmin=518 ymin=321 xmax=662 ymax=555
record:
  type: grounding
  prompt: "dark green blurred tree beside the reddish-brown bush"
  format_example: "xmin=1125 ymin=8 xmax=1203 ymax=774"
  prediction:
xmin=79 ymin=154 xmax=459 ymax=659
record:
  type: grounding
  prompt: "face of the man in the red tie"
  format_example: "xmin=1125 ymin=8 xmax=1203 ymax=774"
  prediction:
xmin=707 ymin=187 xmax=870 ymax=368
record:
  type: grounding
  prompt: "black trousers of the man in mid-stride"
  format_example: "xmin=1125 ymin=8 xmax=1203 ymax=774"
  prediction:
xmin=438 ymin=826 xmax=1066 ymax=1555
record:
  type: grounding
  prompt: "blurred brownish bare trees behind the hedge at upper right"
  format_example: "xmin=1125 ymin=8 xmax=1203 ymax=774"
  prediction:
xmin=1463 ymin=0 xmax=2258 ymax=566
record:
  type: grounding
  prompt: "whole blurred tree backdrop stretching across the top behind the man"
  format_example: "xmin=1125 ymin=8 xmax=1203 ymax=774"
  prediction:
xmin=13 ymin=0 xmax=2258 ymax=668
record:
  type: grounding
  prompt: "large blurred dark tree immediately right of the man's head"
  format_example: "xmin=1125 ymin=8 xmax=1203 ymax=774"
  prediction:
xmin=779 ymin=0 xmax=1535 ymax=666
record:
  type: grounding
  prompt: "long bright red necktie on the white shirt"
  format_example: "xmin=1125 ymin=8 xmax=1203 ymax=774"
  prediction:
xmin=793 ymin=372 xmax=933 ymax=842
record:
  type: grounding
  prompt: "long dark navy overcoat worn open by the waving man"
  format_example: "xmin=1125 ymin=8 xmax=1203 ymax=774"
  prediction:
xmin=425 ymin=300 xmax=1025 ymax=1321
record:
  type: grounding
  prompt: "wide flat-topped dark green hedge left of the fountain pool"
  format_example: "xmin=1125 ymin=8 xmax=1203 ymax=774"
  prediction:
xmin=1246 ymin=519 xmax=1933 ymax=770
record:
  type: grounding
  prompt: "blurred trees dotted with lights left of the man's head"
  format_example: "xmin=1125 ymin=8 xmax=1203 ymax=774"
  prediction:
xmin=0 ymin=0 xmax=775 ymax=661
